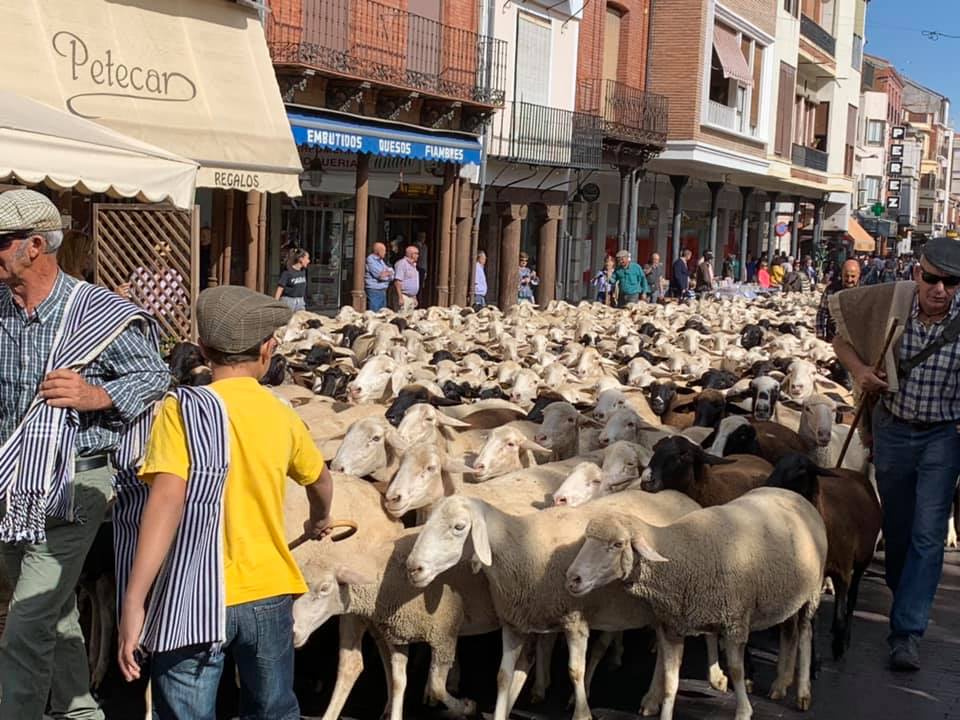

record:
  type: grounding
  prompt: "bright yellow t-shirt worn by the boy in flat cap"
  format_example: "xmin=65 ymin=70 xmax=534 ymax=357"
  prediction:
xmin=140 ymin=378 xmax=323 ymax=606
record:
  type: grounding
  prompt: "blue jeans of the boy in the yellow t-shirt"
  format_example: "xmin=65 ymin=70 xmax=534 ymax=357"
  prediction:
xmin=150 ymin=595 xmax=300 ymax=720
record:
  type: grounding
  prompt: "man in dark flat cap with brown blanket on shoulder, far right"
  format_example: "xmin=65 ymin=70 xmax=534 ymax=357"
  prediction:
xmin=829 ymin=238 xmax=960 ymax=671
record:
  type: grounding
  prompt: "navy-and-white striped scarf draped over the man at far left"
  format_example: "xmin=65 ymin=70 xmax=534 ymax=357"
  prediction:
xmin=0 ymin=282 xmax=159 ymax=543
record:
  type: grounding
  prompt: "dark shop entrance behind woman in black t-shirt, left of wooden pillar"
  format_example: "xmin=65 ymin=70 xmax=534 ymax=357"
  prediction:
xmin=283 ymin=207 xmax=356 ymax=313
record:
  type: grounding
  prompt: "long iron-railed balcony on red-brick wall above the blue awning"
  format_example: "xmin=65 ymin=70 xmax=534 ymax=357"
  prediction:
xmin=267 ymin=0 xmax=507 ymax=107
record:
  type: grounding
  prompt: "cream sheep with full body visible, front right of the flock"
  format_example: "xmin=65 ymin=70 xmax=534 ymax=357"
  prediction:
xmin=567 ymin=488 xmax=827 ymax=720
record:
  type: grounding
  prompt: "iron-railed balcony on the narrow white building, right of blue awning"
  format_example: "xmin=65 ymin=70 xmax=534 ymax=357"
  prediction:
xmin=491 ymin=101 xmax=603 ymax=169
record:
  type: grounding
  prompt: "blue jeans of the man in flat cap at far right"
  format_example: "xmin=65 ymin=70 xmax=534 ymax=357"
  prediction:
xmin=873 ymin=403 xmax=960 ymax=639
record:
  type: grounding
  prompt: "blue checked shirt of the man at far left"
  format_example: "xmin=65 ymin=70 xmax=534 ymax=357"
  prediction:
xmin=0 ymin=272 xmax=170 ymax=455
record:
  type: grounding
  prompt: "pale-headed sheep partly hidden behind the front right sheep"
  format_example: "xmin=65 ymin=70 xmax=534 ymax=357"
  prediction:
xmin=407 ymin=491 xmax=698 ymax=720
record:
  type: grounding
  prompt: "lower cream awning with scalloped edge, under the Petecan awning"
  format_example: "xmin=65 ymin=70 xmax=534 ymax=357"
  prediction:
xmin=0 ymin=91 xmax=197 ymax=208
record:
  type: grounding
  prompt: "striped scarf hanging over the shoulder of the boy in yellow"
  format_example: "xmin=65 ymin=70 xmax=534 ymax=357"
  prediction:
xmin=113 ymin=386 xmax=230 ymax=652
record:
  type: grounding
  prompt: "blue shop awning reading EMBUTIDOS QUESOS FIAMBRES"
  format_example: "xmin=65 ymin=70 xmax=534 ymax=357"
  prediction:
xmin=288 ymin=112 xmax=481 ymax=165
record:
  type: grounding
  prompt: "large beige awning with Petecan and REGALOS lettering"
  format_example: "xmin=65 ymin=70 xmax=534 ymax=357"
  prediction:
xmin=0 ymin=0 xmax=302 ymax=196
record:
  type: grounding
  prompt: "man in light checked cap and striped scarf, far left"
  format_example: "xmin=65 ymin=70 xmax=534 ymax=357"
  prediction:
xmin=0 ymin=190 xmax=170 ymax=720
